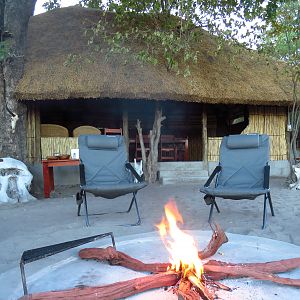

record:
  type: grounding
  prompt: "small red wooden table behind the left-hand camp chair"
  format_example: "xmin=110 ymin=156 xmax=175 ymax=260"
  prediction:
xmin=42 ymin=159 xmax=80 ymax=198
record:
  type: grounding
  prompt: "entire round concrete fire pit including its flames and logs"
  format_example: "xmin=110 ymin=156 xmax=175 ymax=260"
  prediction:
xmin=5 ymin=204 xmax=300 ymax=300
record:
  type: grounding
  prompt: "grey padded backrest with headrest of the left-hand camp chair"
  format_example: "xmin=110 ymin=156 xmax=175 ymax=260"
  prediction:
xmin=78 ymin=134 xmax=133 ymax=186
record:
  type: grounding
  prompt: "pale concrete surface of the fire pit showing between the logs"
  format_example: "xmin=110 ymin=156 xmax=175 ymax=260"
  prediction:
xmin=3 ymin=231 xmax=300 ymax=300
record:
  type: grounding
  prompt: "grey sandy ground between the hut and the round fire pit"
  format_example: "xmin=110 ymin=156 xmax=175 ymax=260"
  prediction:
xmin=0 ymin=178 xmax=300 ymax=273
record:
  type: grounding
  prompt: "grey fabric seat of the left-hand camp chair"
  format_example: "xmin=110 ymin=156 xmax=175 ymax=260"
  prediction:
xmin=81 ymin=182 xmax=147 ymax=199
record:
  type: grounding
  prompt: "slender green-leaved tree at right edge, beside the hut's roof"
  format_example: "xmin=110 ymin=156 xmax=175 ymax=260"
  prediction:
xmin=260 ymin=0 xmax=300 ymax=164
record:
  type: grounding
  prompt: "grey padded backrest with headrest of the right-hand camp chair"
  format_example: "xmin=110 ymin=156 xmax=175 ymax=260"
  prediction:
xmin=218 ymin=134 xmax=269 ymax=188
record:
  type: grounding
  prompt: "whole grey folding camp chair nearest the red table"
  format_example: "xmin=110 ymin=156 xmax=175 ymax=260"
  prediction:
xmin=76 ymin=134 xmax=147 ymax=226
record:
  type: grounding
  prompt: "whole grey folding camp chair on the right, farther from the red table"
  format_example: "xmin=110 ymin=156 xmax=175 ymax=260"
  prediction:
xmin=200 ymin=134 xmax=274 ymax=229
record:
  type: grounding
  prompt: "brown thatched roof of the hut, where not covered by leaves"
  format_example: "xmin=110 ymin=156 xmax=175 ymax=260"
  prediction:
xmin=16 ymin=6 xmax=292 ymax=105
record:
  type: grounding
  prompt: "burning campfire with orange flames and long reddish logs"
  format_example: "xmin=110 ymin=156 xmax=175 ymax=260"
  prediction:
xmin=23 ymin=201 xmax=300 ymax=300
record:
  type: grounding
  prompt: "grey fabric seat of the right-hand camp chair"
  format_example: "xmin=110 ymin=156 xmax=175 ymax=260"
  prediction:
xmin=200 ymin=186 xmax=269 ymax=200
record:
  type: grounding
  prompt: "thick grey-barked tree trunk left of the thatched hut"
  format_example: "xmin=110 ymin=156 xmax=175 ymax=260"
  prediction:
xmin=0 ymin=0 xmax=36 ymax=161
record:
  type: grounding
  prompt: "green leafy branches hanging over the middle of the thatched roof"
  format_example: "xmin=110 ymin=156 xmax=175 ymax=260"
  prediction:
xmin=84 ymin=1 xmax=204 ymax=76
